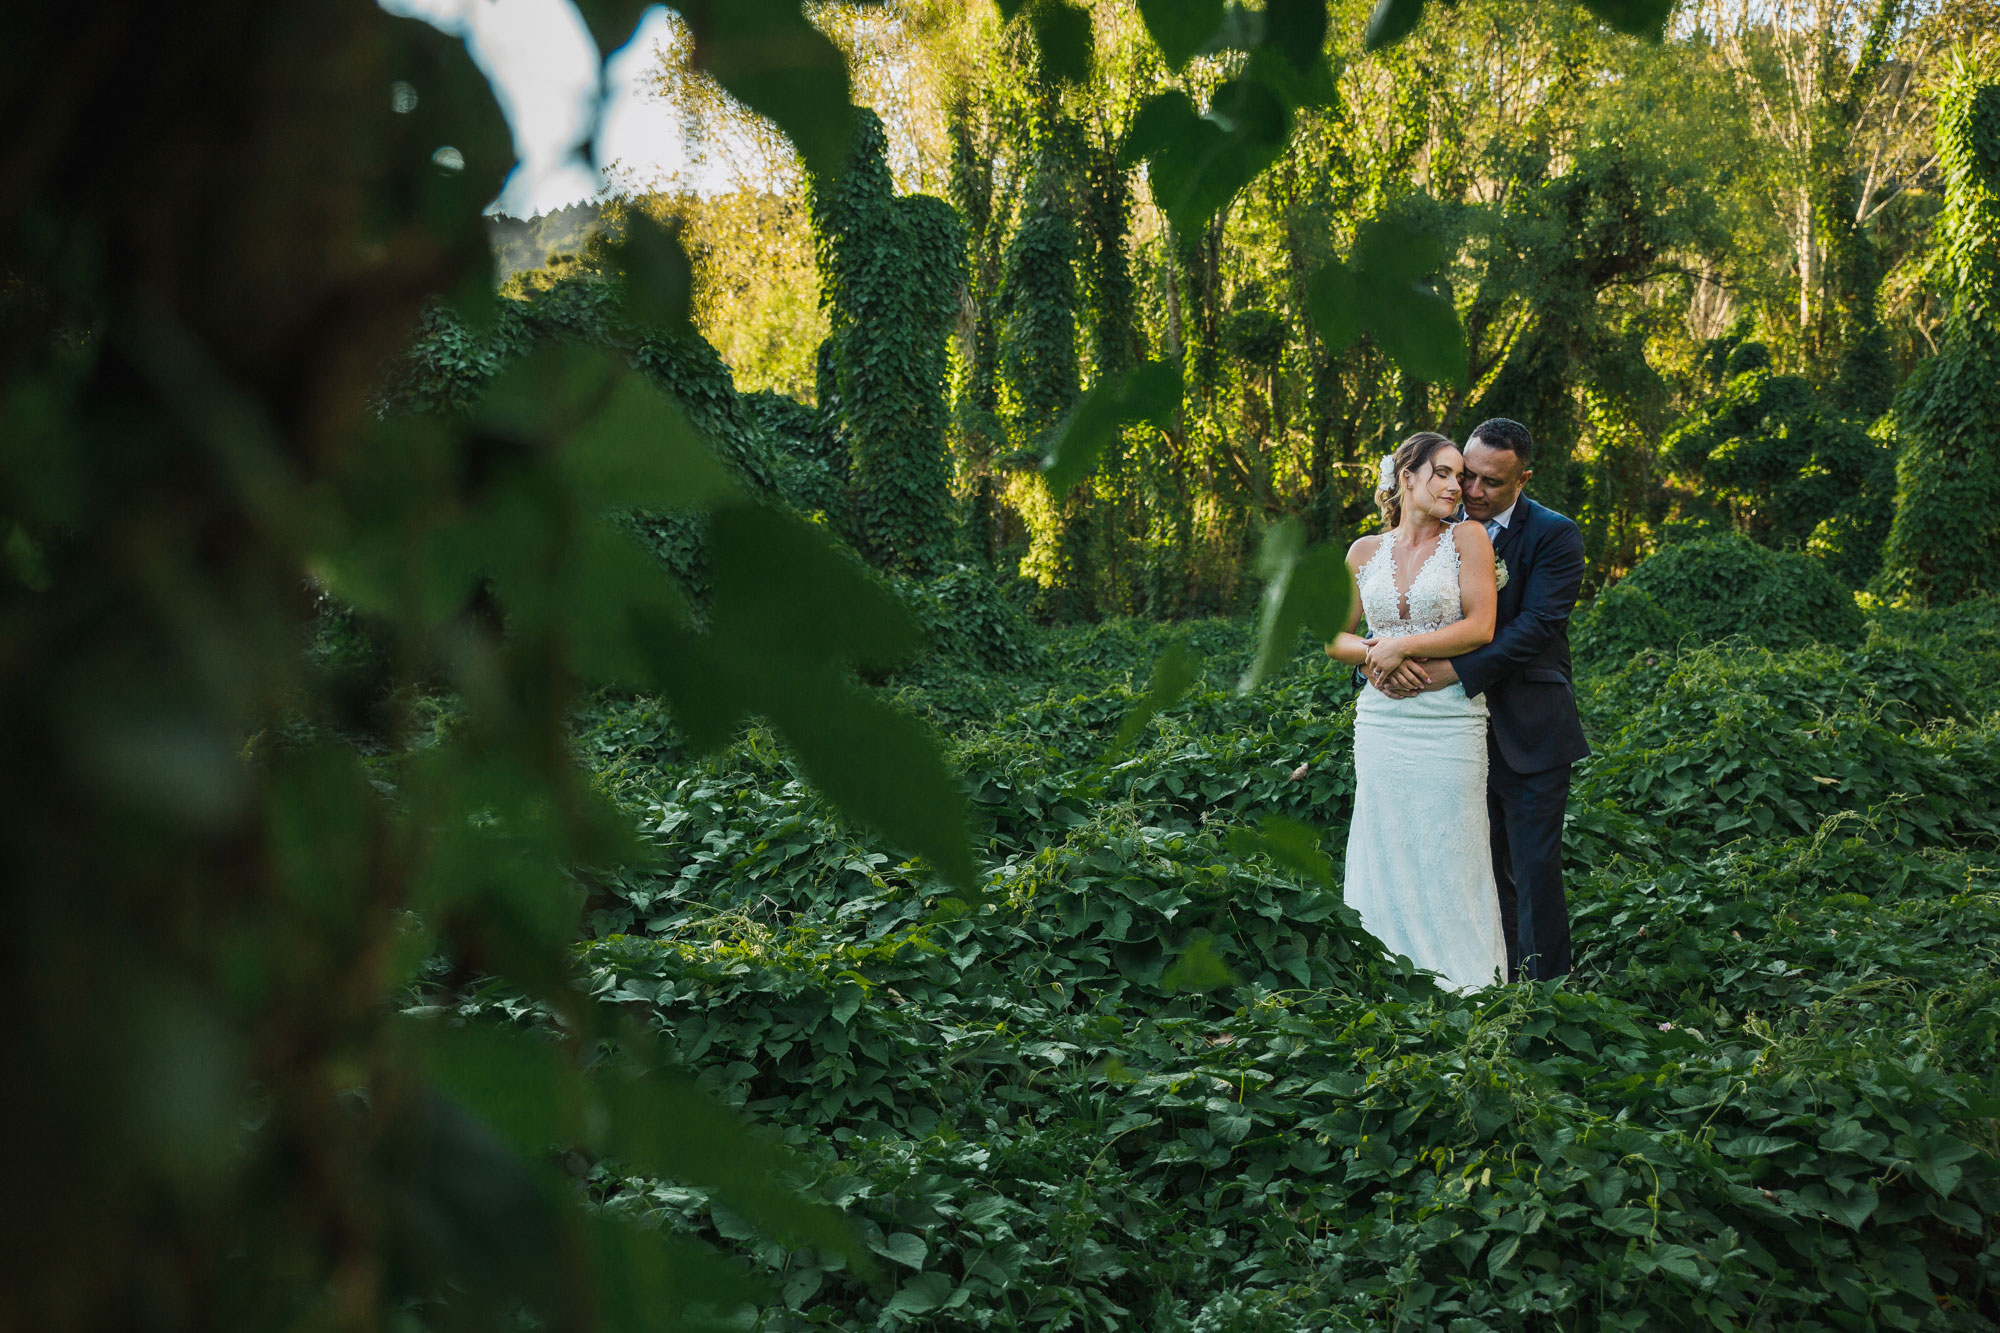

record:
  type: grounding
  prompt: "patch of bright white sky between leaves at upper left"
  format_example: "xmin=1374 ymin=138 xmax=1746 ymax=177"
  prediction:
xmin=380 ymin=0 xmax=748 ymax=218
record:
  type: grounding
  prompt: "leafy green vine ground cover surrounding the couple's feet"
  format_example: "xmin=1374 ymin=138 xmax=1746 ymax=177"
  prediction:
xmin=456 ymin=556 xmax=2000 ymax=1333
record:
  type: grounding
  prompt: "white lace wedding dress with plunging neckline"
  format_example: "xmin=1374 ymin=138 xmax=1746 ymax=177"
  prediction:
xmin=1346 ymin=532 xmax=1506 ymax=991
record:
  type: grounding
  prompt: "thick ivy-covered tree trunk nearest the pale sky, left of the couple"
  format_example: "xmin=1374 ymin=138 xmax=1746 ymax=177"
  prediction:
xmin=812 ymin=110 xmax=966 ymax=574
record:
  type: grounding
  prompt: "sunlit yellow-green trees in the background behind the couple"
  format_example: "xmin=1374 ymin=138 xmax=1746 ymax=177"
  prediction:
xmin=648 ymin=0 xmax=2000 ymax=604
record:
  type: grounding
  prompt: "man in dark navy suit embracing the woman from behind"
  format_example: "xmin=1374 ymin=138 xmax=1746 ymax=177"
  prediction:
xmin=1384 ymin=416 xmax=1590 ymax=981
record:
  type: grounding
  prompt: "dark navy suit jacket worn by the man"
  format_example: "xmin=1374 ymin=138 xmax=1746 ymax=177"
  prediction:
xmin=1452 ymin=496 xmax=1590 ymax=773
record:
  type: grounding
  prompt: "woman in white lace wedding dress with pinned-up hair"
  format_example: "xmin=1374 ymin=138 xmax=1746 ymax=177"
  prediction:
xmin=1326 ymin=430 xmax=1506 ymax=991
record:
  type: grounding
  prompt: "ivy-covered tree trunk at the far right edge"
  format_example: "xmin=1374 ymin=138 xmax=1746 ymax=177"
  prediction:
xmin=1882 ymin=60 xmax=2000 ymax=602
